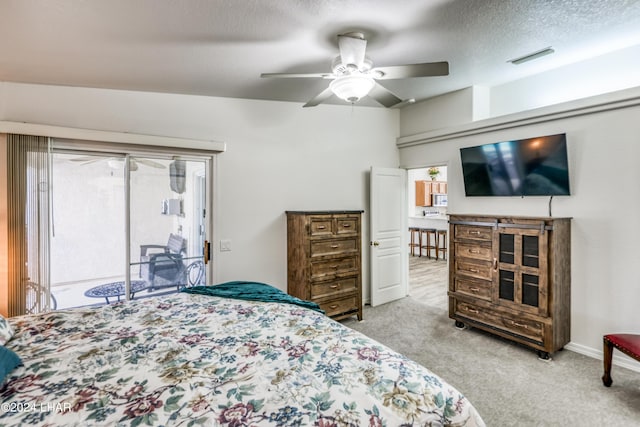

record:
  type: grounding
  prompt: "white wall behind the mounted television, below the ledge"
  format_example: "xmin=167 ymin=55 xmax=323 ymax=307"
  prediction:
xmin=400 ymin=89 xmax=640 ymax=364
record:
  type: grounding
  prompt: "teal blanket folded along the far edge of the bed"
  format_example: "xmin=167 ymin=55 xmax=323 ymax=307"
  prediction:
xmin=181 ymin=281 xmax=324 ymax=314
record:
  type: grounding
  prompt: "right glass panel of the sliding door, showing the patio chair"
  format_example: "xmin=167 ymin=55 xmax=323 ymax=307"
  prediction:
xmin=129 ymin=157 xmax=207 ymax=293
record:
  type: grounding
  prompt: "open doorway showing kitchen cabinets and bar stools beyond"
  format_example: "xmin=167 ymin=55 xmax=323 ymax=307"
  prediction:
xmin=407 ymin=165 xmax=449 ymax=309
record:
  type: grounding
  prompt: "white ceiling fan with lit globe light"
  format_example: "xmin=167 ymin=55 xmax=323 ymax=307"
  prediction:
xmin=260 ymin=32 xmax=449 ymax=108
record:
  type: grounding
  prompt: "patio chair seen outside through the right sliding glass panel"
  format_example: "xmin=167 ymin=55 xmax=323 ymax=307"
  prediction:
xmin=140 ymin=234 xmax=186 ymax=290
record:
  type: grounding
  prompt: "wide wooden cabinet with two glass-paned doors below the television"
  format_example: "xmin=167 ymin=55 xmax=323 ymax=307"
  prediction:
xmin=448 ymin=215 xmax=571 ymax=359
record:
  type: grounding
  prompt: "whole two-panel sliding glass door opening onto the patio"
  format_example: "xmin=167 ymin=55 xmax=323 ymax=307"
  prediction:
xmin=49 ymin=149 xmax=211 ymax=309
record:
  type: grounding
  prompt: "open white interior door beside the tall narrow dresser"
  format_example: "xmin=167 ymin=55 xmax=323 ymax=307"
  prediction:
xmin=369 ymin=167 xmax=409 ymax=307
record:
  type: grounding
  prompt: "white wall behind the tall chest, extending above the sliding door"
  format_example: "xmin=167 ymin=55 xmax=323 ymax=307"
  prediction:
xmin=0 ymin=83 xmax=399 ymax=297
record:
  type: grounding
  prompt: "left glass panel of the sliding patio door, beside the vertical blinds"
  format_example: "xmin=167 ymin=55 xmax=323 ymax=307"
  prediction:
xmin=50 ymin=152 xmax=126 ymax=308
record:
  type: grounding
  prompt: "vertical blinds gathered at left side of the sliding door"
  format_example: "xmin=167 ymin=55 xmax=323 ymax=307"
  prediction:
xmin=7 ymin=134 xmax=55 ymax=316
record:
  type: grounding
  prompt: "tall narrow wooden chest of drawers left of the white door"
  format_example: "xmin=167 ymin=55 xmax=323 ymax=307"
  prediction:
xmin=286 ymin=211 xmax=363 ymax=320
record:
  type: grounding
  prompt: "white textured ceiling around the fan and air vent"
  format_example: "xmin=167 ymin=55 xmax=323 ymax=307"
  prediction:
xmin=0 ymin=0 xmax=640 ymax=105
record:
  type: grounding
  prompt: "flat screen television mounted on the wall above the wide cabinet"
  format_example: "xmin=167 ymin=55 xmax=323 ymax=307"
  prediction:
xmin=460 ymin=133 xmax=570 ymax=196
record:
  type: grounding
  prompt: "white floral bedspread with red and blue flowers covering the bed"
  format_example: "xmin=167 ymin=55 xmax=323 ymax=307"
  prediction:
xmin=0 ymin=294 xmax=484 ymax=427
